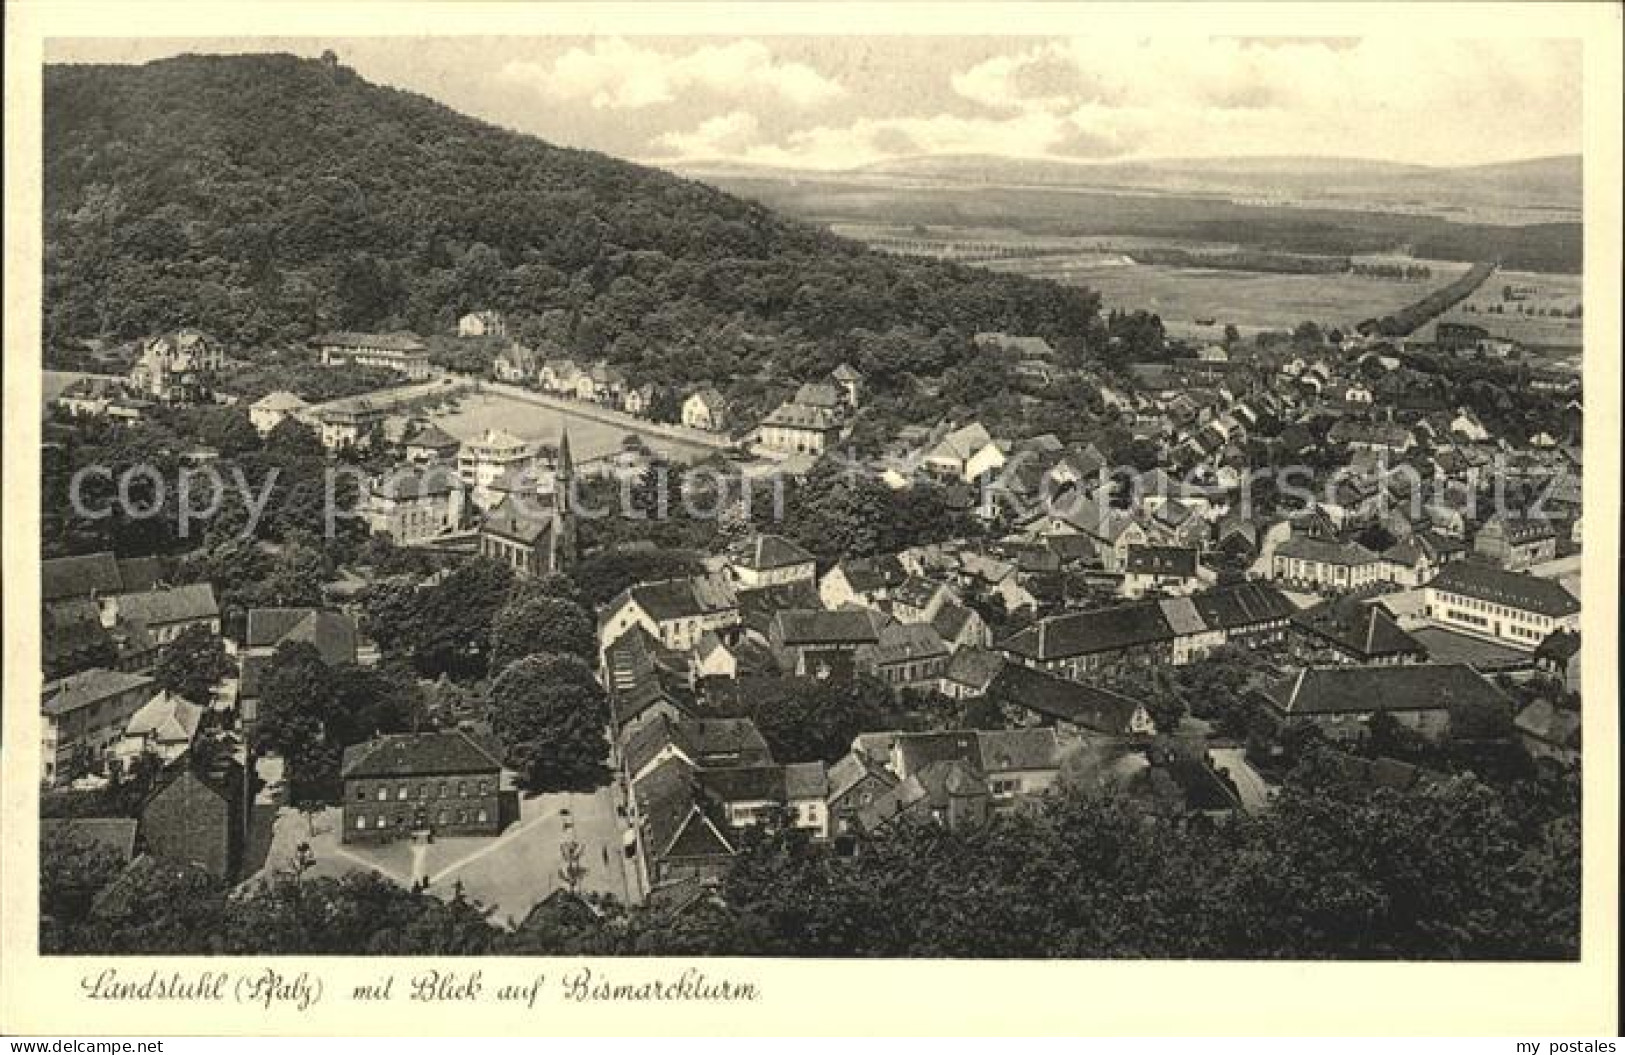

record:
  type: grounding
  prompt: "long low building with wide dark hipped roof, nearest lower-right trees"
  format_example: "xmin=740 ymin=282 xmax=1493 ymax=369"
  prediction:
xmin=1263 ymin=663 xmax=1511 ymax=740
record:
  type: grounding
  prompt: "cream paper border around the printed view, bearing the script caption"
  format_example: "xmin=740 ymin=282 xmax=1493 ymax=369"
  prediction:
xmin=0 ymin=2 xmax=1622 ymax=1037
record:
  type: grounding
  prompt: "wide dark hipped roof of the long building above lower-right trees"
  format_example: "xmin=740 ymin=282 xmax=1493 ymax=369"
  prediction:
xmin=1264 ymin=663 xmax=1506 ymax=717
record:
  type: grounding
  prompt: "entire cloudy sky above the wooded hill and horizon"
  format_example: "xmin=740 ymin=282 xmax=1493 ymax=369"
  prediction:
xmin=47 ymin=36 xmax=1581 ymax=169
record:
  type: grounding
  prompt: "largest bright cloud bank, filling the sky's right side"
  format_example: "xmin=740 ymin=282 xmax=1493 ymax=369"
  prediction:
xmin=951 ymin=37 xmax=1581 ymax=164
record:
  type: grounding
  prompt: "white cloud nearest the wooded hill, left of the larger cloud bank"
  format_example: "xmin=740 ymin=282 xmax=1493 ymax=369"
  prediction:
xmin=501 ymin=37 xmax=845 ymax=109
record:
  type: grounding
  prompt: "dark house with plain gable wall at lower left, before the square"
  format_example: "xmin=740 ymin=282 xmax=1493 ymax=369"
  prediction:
xmin=140 ymin=758 xmax=244 ymax=881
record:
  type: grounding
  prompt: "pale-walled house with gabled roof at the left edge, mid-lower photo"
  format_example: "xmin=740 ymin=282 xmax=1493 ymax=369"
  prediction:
xmin=39 ymin=668 xmax=154 ymax=785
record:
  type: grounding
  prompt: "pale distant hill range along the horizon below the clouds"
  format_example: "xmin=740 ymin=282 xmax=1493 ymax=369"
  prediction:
xmin=673 ymin=154 xmax=1581 ymax=221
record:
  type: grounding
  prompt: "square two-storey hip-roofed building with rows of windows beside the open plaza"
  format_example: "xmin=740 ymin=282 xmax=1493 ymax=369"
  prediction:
xmin=340 ymin=730 xmax=502 ymax=842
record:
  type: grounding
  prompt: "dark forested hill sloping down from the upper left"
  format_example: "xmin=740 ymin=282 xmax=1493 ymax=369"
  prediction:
xmin=44 ymin=55 xmax=1099 ymax=382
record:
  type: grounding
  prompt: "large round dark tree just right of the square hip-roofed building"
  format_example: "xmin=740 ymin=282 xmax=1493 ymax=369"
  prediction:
xmin=489 ymin=653 xmax=609 ymax=792
